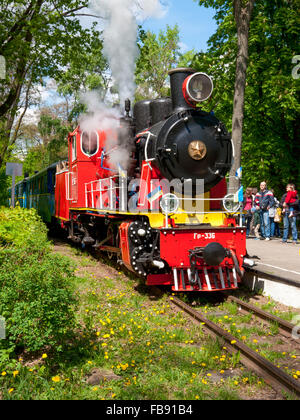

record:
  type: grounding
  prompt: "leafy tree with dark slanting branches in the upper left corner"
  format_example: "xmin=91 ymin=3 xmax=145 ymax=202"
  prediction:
xmin=0 ymin=0 xmax=105 ymax=168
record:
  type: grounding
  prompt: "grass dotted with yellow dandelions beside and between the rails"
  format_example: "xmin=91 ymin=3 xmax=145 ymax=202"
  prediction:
xmin=0 ymin=241 xmax=297 ymax=400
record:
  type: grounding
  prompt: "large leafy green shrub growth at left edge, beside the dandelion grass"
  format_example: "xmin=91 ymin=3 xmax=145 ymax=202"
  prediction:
xmin=0 ymin=209 xmax=76 ymax=351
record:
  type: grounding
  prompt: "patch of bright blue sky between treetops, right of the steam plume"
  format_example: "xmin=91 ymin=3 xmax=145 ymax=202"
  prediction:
xmin=143 ymin=0 xmax=217 ymax=52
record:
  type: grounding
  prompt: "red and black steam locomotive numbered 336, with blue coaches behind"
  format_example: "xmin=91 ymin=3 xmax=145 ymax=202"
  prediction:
xmin=11 ymin=68 xmax=246 ymax=291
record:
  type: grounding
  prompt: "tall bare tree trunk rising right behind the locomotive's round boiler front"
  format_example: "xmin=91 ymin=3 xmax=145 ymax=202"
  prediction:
xmin=229 ymin=0 xmax=255 ymax=192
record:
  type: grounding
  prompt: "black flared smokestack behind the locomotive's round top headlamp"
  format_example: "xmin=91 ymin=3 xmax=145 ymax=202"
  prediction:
xmin=169 ymin=68 xmax=196 ymax=112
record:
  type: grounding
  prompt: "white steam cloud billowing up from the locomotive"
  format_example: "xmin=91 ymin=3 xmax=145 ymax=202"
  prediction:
xmin=80 ymin=0 xmax=165 ymax=170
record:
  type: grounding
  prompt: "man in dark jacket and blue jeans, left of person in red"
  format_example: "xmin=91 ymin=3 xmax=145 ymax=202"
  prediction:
xmin=254 ymin=181 xmax=275 ymax=241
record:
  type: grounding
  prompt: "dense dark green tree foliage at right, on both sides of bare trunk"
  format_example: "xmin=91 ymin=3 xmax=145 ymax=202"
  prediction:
xmin=193 ymin=0 xmax=300 ymax=194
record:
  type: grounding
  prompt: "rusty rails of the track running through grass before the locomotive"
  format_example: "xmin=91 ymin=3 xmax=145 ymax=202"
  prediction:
xmin=170 ymin=296 xmax=300 ymax=399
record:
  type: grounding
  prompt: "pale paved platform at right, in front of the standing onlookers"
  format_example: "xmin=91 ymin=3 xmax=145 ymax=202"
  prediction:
xmin=247 ymin=238 xmax=300 ymax=284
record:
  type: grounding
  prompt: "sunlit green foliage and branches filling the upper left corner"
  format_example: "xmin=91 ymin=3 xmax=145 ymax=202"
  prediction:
xmin=0 ymin=0 xmax=106 ymax=167
